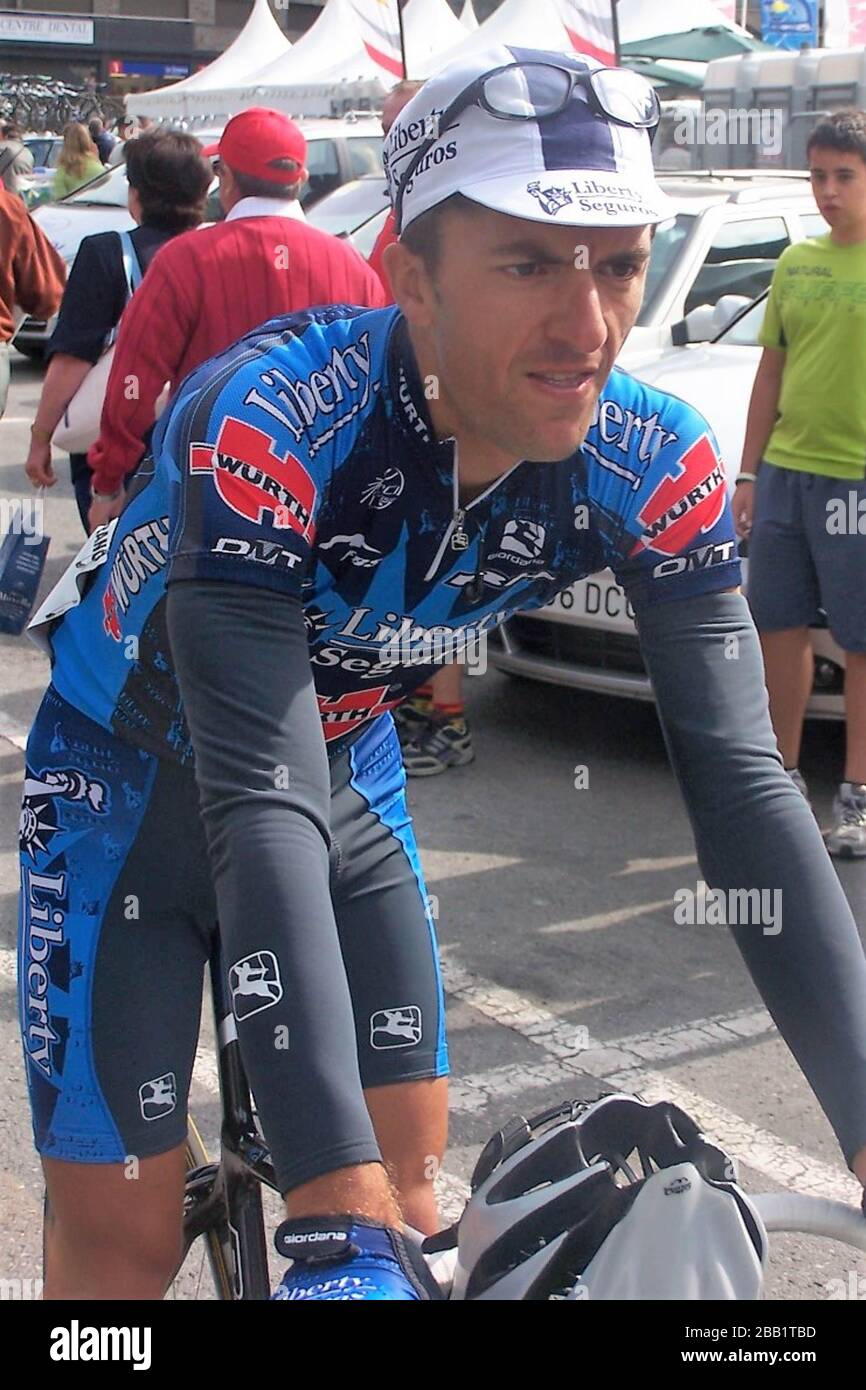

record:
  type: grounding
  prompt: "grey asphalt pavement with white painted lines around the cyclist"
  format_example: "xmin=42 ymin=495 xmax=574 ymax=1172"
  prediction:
xmin=0 ymin=354 xmax=866 ymax=1300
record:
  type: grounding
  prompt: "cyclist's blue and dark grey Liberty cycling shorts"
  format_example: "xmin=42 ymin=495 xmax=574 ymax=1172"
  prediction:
xmin=18 ymin=688 xmax=448 ymax=1163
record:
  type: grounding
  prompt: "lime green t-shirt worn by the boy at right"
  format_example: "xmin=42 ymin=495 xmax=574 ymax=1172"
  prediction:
xmin=760 ymin=235 xmax=866 ymax=480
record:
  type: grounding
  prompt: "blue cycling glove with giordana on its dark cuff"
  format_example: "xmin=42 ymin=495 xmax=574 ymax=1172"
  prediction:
xmin=271 ymin=1216 xmax=441 ymax=1302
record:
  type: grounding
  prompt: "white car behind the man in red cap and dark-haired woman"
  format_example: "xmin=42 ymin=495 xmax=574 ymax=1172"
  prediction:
xmin=15 ymin=117 xmax=384 ymax=357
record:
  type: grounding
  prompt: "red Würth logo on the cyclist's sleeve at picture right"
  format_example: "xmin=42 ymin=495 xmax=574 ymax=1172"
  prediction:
xmin=628 ymin=435 xmax=727 ymax=556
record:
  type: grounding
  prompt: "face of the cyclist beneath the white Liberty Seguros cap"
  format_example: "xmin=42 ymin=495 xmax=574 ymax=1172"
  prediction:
xmin=398 ymin=207 xmax=651 ymax=467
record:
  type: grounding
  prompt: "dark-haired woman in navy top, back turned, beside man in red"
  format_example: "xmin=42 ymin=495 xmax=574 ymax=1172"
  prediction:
xmin=25 ymin=131 xmax=213 ymax=531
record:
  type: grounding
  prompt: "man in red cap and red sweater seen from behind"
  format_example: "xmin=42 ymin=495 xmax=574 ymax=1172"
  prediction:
xmin=83 ymin=107 xmax=386 ymax=528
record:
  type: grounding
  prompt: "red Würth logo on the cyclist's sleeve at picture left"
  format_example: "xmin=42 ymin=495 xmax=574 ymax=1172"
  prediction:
xmin=189 ymin=416 xmax=316 ymax=541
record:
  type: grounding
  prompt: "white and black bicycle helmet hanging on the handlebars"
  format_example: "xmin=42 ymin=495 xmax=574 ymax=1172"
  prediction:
xmin=424 ymin=1094 xmax=766 ymax=1300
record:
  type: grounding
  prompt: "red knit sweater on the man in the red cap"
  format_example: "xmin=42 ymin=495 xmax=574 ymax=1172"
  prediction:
xmin=88 ymin=205 xmax=386 ymax=492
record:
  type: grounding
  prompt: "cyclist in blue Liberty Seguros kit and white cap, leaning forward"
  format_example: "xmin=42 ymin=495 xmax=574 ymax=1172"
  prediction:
xmin=19 ymin=47 xmax=866 ymax=1298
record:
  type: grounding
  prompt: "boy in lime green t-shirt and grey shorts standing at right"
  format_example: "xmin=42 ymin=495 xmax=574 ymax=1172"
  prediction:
xmin=733 ymin=110 xmax=866 ymax=858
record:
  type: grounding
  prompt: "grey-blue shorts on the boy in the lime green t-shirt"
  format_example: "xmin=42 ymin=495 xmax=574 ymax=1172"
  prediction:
xmin=748 ymin=461 xmax=866 ymax=652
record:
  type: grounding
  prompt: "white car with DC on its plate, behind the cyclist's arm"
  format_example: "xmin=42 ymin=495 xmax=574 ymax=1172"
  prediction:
xmin=489 ymin=296 xmax=845 ymax=720
